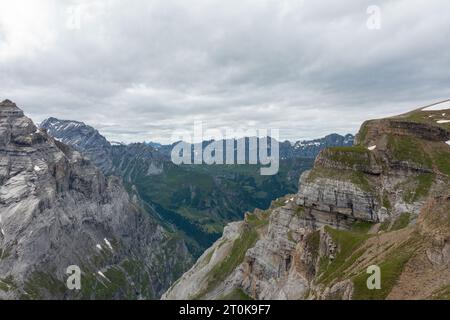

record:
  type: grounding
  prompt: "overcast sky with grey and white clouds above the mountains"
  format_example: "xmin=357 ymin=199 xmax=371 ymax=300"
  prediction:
xmin=0 ymin=0 xmax=450 ymax=142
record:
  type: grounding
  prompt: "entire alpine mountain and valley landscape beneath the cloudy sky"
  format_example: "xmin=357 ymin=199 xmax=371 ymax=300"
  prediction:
xmin=0 ymin=100 xmax=450 ymax=300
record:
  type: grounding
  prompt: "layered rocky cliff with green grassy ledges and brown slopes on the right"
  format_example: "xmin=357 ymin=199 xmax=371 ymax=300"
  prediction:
xmin=163 ymin=103 xmax=450 ymax=299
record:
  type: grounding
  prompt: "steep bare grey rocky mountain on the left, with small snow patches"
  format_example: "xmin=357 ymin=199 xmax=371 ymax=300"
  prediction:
xmin=0 ymin=101 xmax=190 ymax=299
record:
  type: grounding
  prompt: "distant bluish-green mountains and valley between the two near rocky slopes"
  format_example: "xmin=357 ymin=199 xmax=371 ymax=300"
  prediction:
xmin=41 ymin=118 xmax=353 ymax=255
